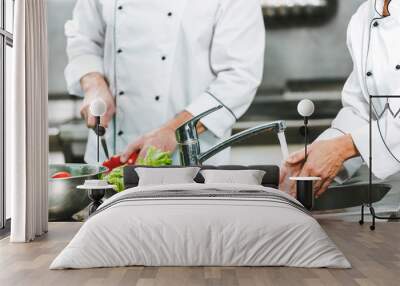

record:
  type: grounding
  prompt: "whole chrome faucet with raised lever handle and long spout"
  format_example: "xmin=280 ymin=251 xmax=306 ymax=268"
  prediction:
xmin=176 ymin=105 xmax=286 ymax=166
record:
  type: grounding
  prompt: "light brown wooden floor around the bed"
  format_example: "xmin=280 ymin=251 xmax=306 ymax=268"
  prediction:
xmin=0 ymin=220 xmax=400 ymax=286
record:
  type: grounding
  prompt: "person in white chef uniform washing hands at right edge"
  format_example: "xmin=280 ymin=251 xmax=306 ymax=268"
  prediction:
xmin=281 ymin=0 xmax=400 ymax=196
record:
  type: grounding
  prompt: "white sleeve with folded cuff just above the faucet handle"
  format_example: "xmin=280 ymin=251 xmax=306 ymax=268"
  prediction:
xmin=186 ymin=0 xmax=265 ymax=137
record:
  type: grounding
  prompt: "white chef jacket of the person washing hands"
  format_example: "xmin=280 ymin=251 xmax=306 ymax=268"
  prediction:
xmin=320 ymin=0 xmax=400 ymax=180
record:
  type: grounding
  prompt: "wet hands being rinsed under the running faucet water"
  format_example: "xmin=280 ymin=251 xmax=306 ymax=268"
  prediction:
xmin=285 ymin=135 xmax=359 ymax=197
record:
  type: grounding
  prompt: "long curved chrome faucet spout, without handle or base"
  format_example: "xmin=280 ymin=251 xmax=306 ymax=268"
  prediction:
xmin=198 ymin=121 xmax=287 ymax=164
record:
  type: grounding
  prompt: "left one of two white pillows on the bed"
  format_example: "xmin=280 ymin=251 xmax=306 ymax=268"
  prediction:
xmin=135 ymin=167 xmax=200 ymax=186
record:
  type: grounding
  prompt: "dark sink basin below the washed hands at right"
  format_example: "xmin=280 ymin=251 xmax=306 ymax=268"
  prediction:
xmin=313 ymin=183 xmax=392 ymax=211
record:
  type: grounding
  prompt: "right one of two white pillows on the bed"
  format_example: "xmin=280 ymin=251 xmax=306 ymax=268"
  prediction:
xmin=200 ymin=170 xmax=266 ymax=185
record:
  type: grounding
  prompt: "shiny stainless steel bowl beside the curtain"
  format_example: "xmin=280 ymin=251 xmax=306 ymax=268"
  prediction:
xmin=49 ymin=164 xmax=108 ymax=221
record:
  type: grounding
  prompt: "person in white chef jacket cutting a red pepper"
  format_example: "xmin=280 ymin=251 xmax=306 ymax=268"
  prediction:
xmin=65 ymin=0 xmax=265 ymax=163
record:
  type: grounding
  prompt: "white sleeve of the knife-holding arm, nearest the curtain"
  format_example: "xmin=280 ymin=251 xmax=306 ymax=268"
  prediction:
xmin=65 ymin=0 xmax=105 ymax=95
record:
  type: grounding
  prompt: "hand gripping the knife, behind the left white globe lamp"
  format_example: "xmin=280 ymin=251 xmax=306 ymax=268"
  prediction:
xmin=80 ymin=73 xmax=115 ymax=128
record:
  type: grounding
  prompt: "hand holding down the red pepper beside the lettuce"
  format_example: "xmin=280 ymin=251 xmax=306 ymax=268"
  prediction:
xmin=121 ymin=111 xmax=205 ymax=163
